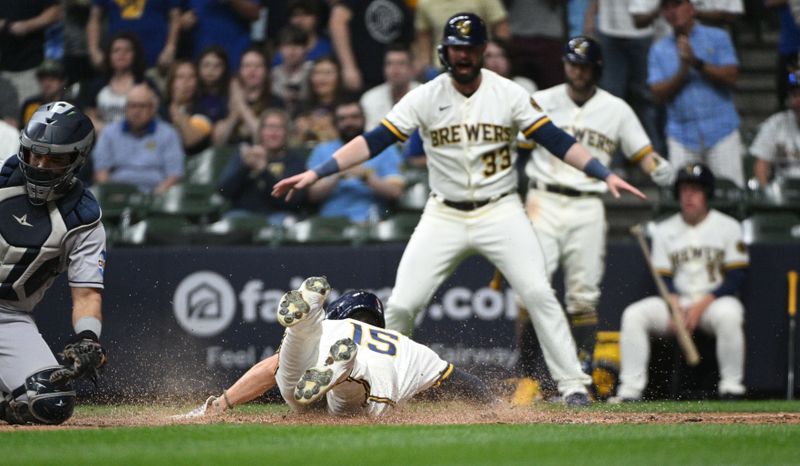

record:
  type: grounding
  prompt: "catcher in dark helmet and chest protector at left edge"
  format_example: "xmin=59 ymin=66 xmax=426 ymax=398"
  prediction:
xmin=0 ymin=102 xmax=106 ymax=424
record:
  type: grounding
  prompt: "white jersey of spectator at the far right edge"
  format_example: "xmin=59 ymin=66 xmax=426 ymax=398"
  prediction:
xmin=750 ymin=110 xmax=800 ymax=178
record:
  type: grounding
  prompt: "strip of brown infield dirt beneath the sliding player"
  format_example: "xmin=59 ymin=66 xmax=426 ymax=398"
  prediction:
xmin=6 ymin=403 xmax=800 ymax=432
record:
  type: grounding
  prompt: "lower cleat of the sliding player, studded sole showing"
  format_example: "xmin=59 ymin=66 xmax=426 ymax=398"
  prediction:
xmin=294 ymin=338 xmax=358 ymax=404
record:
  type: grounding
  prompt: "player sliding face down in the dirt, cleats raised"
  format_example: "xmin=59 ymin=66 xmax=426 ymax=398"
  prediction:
xmin=174 ymin=277 xmax=495 ymax=420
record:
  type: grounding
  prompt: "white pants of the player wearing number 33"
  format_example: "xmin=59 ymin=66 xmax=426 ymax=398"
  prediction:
xmin=386 ymin=195 xmax=591 ymax=396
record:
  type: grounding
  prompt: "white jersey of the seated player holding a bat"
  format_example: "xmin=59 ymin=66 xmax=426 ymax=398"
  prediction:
xmin=653 ymin=209 xmax=749 ymax=301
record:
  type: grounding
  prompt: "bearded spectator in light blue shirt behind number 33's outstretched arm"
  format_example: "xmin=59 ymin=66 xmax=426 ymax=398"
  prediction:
xmin=306 ymin=101 xmax=405 ymax=223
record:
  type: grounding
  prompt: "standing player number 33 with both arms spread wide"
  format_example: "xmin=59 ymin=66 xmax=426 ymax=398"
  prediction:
xmin=273 ymin=13 xmax=644 ymax=405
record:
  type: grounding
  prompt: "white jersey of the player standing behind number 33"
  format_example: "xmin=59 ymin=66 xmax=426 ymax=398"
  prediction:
xmin=525 ymin=84 xmax=653 ymax=193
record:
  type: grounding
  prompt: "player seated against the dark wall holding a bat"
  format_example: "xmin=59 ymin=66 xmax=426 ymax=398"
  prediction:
xmin=610 ymin=164 xmax=749 ymax=402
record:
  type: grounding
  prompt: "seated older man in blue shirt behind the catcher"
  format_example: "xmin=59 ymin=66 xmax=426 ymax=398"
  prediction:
xmin=93 ymin=84 xmax=185 ymax=193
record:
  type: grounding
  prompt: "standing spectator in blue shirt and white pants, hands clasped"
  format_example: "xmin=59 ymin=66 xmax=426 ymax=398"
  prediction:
xmin=647 ymin=0 xmax=744 ymax=186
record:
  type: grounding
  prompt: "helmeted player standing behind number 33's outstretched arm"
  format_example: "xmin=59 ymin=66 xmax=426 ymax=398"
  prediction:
xmin=510 ymin=36 xmax=673 ymax=400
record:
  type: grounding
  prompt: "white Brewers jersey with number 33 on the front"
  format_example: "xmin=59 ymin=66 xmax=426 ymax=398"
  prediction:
xmin=382 ymin=69 xmax=550 ymax=201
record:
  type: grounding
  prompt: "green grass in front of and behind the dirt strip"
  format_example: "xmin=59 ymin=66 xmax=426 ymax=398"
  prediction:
xmin=0 ymin=402 xmax=800 ymax=466
